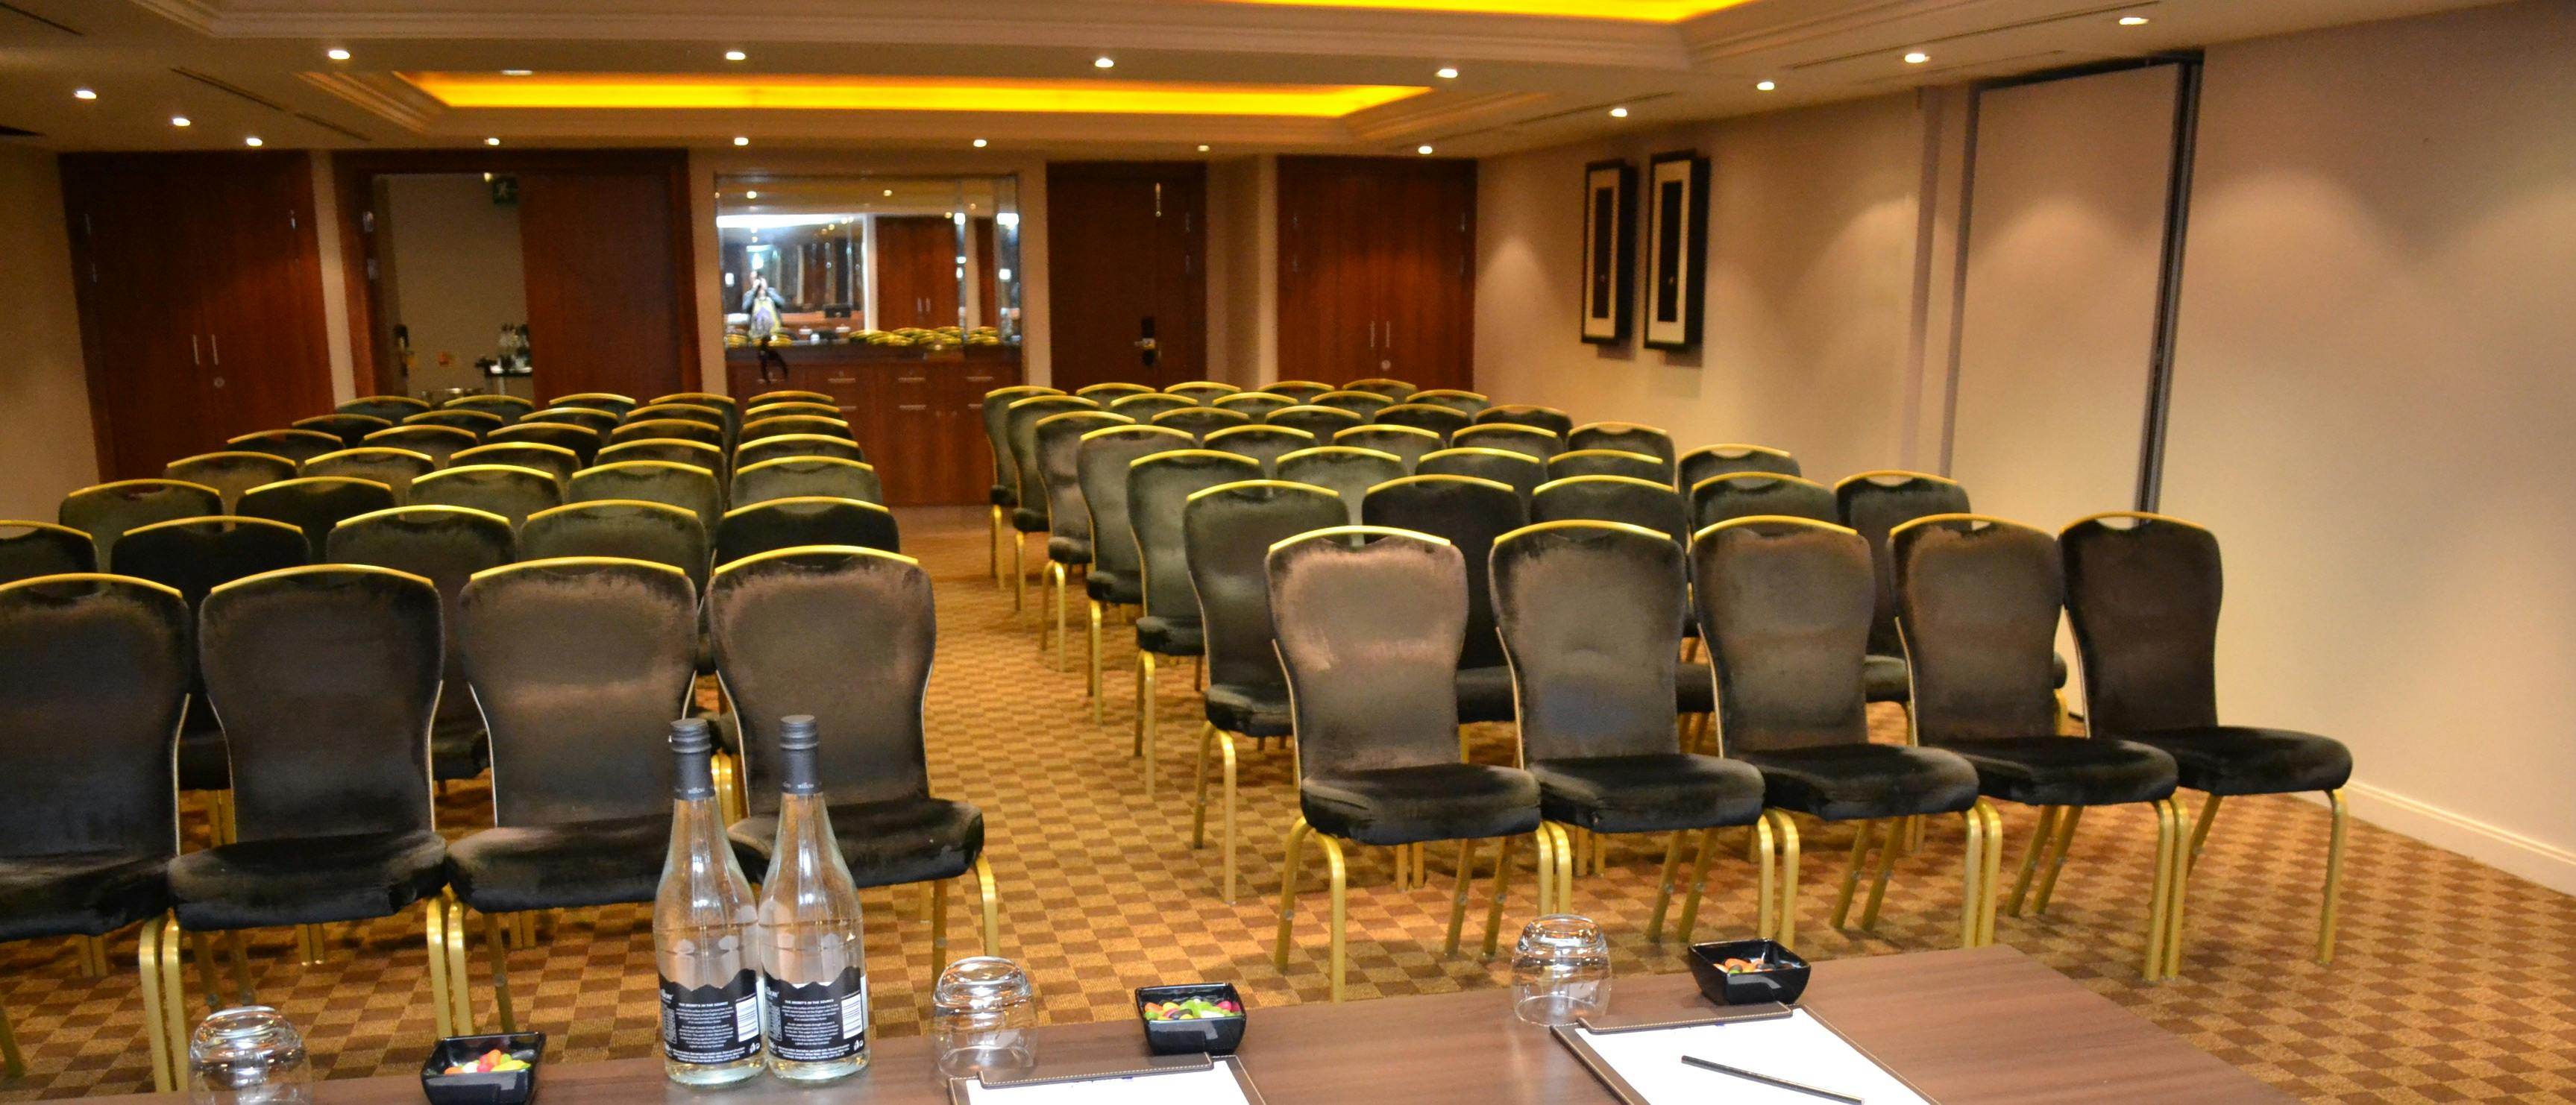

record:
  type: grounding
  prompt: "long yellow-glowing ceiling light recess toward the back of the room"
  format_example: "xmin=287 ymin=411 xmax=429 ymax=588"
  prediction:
xmin=399 ymin=72 xmax=1427 ymax=119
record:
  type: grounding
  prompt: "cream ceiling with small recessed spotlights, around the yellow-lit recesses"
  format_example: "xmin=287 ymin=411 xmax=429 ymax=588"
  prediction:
xmin=0 ymin=0 xmax=2491 ymax=157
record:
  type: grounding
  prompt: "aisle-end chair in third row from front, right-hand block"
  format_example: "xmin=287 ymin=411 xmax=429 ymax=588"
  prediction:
xmin=1125 ymin=448 xmax=1262 ymax=801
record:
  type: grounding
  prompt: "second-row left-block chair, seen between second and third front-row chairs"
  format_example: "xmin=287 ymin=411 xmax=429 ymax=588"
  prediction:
xmin=322 ymin=505 xmax=518 ymax=783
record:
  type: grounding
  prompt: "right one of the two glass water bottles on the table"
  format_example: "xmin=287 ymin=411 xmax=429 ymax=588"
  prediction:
xmin=760 ymin=714 xmax=868 ymax=1082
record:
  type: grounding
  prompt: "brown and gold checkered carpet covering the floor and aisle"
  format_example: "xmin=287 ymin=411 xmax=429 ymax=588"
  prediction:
xmin=0 ymin=510 xmax=2576 ymax=1103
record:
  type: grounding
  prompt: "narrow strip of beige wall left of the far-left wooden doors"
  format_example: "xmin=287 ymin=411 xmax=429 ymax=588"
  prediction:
xmin=0 ymin=149 xmax=98 ymax=523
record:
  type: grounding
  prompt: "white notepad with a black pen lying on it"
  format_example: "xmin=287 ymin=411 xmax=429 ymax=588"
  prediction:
xmin=1571 ymin=1010 xmax=1932 ymax=1105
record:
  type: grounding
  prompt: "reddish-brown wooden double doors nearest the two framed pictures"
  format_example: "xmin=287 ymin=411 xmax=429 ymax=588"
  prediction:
xmin=1278 ymin=157 xmax=1476 ymax=389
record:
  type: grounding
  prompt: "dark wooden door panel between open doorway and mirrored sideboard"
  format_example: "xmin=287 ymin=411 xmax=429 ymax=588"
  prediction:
xmin=515 ymin=168 xmax=696 ymax=399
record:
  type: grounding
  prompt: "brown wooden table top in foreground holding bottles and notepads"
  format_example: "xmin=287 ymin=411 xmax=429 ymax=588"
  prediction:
xmin=100 ymin=945 xmax=2290 ymax=1105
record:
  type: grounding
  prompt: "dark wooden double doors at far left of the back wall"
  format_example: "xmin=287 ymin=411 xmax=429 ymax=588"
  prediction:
xmin=62 ymin=152 xmax=333 ymax=479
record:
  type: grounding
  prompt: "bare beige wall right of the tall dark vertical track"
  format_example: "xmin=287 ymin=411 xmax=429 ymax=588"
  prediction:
xmin=2164 ymin=2 xmax=2576 ymax=891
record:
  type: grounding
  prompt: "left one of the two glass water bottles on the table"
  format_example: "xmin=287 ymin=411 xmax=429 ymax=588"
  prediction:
xmin=652 ymin=719 xmax=760 ymax=1087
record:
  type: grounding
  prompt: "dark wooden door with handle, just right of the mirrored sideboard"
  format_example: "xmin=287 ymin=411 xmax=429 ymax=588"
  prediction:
xmin=1046 ymin=163 xmax=1208 ymax=391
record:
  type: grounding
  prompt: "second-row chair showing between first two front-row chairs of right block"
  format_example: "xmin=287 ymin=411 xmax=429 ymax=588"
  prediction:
xmin=1360 ymin=473 xmax=1536 ymax=721
